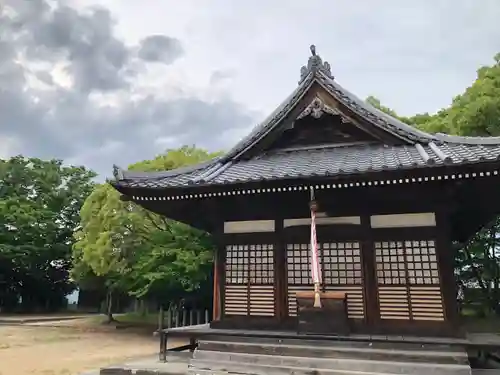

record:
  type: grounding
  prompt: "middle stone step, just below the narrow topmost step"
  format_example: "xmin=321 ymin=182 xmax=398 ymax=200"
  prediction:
xmin=198 ymin=340 xmax=468 ymax=364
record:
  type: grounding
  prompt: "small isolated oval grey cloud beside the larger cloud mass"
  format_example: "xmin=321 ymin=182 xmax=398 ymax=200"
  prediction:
xmin=138 ymin=35 xmax=184 ymax=64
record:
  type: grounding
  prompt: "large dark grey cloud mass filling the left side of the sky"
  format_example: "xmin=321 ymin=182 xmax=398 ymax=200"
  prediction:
xmin=0 ymin=0 xmax=254 ymax=175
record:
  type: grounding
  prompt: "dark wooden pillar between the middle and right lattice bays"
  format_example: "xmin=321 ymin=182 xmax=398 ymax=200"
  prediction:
xmin=361 ymin=215 xmax=380 ymax=331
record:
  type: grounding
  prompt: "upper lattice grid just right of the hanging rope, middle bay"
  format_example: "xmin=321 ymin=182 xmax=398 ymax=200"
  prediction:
xmin=320 ymin=242 xmax=363 ymax=285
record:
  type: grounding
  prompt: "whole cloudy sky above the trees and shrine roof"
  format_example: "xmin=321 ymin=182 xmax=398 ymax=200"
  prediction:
xmin=0 ymin=0 xmax=500 ymax=176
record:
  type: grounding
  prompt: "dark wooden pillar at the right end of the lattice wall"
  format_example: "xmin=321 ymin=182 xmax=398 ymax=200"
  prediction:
xmin=436 ymin=209 xmax=462 ymax=335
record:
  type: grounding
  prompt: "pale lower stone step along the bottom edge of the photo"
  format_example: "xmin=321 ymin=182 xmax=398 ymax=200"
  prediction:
xmin=190 ymin=350 xmax=470 ymax=375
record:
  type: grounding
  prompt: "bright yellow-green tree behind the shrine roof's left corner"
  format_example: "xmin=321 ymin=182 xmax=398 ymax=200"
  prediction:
xmin=73 ymin=146 xmax=217 ymax=321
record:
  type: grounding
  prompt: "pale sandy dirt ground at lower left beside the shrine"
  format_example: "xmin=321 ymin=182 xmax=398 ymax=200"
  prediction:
xmin=0 ymin=319 xmax=162 ymax=375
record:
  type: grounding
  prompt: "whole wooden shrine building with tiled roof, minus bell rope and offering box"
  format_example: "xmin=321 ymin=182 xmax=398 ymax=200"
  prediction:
xmin=112 ymin=47 xmax=500 ymax=336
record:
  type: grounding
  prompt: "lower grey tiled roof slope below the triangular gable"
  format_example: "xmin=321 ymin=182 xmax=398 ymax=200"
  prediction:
xmin=114 ymin=143 xmax=500 ymax=188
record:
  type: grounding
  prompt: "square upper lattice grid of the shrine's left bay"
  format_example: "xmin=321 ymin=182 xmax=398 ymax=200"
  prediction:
xmin=226 ymin=244 xmax=274 ymax=284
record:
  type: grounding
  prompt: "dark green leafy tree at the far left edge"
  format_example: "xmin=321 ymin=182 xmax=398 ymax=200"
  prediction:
xmin=0 ymin=156 xmax=95 ymax=310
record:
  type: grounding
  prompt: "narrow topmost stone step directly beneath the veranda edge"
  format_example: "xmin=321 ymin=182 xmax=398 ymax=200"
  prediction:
xmin=200 ymin=335 xmax=461 ymax=353
